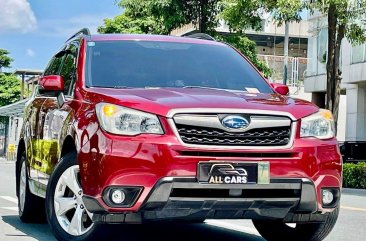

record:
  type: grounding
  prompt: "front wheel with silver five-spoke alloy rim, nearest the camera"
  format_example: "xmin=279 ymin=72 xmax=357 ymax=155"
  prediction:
xmin=46 ymin=152 xmax=100 ymax=241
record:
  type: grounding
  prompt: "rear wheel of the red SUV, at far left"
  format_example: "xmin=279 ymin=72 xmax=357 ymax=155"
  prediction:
xmin=16 ymin=151 xmax=46 ymax=223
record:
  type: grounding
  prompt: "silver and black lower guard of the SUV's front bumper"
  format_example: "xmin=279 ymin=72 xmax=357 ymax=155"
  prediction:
xmin=84 ymin=177 xmax=338 ymax=223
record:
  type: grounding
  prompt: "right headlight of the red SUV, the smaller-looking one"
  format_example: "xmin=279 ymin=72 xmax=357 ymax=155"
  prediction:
xmin=300 ymin=109 xmax=335 ymax=139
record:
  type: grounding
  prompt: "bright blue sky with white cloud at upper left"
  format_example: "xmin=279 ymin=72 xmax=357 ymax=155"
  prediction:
xmin=0 ymin=0 xmax=122 ymax=72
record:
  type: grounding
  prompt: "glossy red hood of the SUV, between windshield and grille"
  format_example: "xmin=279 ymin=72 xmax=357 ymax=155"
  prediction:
xmin=87 ymin=88 xmax=319 ymax=119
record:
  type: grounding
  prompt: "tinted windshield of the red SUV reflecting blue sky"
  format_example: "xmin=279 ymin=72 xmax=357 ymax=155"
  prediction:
xmin=86 ymin=41 xmax=272 ymax=93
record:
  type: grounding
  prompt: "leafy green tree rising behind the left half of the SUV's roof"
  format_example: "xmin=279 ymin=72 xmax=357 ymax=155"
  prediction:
xmin=98 ymin=0 xmax=224 ymax=34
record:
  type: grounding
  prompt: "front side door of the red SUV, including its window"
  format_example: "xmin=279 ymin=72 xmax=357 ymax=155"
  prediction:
xmin=38 ymin=42 xmax=78 ymax=189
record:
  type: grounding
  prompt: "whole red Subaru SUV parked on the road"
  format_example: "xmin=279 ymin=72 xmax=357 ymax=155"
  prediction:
xmin=16 ymin=29 xmax=342 ymax=240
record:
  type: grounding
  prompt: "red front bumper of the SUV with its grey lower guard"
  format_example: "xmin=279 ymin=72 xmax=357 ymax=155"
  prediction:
xmin=78 ymin=124 xmax=342 ymax=222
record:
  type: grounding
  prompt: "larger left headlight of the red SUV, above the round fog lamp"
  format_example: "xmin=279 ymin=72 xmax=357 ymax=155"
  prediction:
xmin=96 ymin=103 xmax=164 ymax=136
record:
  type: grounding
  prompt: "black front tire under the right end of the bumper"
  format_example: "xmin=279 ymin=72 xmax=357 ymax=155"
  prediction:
xmin=253 ymin=207 xmax=339 ymax=241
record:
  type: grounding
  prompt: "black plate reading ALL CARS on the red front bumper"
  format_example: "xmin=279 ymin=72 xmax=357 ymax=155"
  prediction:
xmin=197 ymin=162 xmax=258 ymax=184
